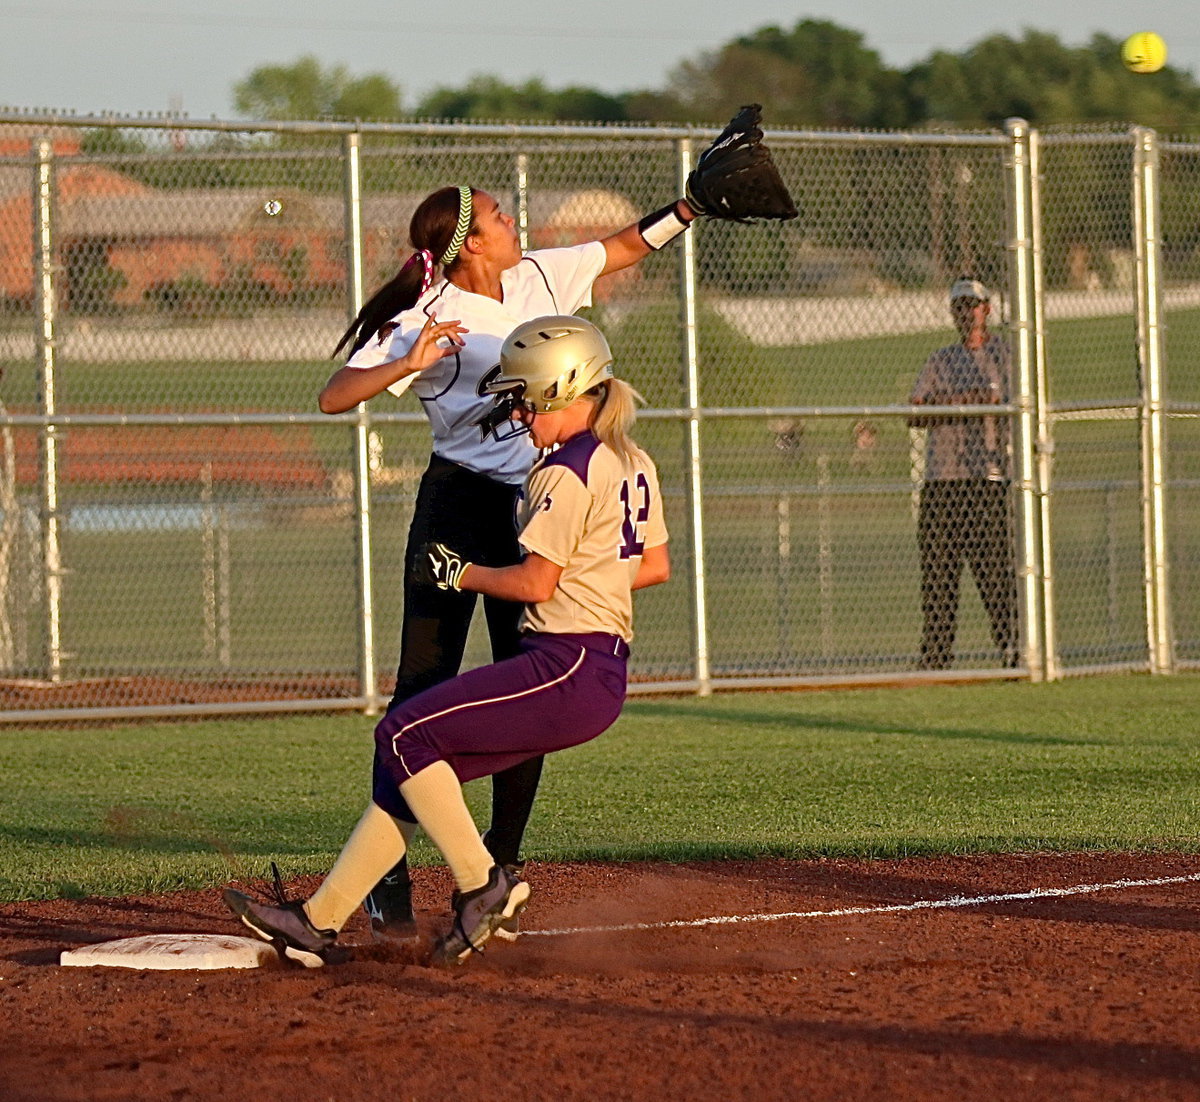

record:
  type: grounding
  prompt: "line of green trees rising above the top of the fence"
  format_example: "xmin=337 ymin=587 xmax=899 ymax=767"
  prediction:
xmin=233 ymin=19 xmax=1200 ymax=133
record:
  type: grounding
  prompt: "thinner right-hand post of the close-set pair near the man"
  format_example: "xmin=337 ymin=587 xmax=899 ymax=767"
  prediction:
xmin=1030 ymin=130 xmax=1062 ymax=681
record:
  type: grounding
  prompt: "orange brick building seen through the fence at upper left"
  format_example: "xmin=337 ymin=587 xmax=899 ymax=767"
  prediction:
xmin=0 ymin=127 xmax=638 ymax=312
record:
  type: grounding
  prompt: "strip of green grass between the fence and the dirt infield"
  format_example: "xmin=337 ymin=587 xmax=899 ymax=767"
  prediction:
xmin=0 ymin=675 xmax=1200 ymax=900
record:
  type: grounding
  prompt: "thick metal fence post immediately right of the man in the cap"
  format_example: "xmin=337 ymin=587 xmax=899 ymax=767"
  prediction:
xmin=1004 ymin=119 xmax=1045 ymax=681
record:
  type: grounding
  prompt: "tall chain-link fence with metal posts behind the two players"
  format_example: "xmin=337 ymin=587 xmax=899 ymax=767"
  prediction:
xmin=0 ymin=109 xmax=1200 ymax=720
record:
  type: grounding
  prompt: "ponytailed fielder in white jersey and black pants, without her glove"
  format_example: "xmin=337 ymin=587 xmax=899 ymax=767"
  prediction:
xmin=319 ymin=186 xmax=696 ymax=941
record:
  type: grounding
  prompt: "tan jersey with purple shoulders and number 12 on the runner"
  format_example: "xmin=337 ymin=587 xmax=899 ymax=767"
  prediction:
xmin=517 ymin=432 xmax=667 ymax=642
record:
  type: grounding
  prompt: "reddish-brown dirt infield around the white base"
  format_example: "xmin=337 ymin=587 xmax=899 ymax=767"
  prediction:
xmin=0 ymin=854 xmax=1200 ymax=1102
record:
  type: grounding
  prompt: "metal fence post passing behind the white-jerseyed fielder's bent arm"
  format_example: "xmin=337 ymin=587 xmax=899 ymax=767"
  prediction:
xmin=343 ymin=131 xmax=379 ymax=715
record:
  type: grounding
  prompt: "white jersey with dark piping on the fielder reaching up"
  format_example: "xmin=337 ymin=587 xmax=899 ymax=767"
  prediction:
xmin=346 ymin=241 xmax=607 ymax=485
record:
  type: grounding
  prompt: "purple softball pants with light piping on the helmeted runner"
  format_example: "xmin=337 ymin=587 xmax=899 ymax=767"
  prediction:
xmin=372 ymin=633 xmax=629 ymax=822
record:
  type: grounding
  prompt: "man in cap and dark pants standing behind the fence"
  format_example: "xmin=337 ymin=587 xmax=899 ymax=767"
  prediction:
xmin=908 ymin=276 xmax=1019 ymax=670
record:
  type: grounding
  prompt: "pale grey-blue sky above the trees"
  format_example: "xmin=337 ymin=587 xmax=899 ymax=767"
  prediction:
xmin=0 ymin=0 xmax=1200 ymax=119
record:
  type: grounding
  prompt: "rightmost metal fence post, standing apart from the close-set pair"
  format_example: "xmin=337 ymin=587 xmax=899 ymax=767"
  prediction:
xmin=1133 ymin=126 xmax=1175 ymax=673
